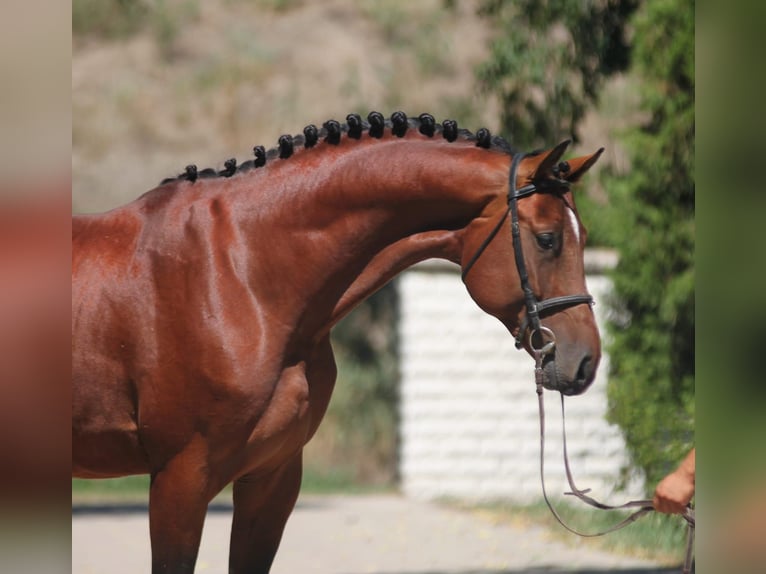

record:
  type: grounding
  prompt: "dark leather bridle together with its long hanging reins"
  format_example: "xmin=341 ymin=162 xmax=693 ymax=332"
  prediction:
xmin=462 ymin=153 xmax=695 ymax=574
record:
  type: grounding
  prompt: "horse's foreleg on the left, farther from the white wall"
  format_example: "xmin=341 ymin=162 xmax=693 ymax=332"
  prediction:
xmin=149 ymin=457 xmax=213 ymax=574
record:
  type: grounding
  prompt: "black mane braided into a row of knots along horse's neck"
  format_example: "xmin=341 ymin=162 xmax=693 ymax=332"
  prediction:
xmin=160 ymin=112 xmax=514 ymax=185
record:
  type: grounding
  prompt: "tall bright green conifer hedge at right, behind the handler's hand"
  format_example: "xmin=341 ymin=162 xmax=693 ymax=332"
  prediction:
xmin=607 ymin=0 xmax=695 ymax=488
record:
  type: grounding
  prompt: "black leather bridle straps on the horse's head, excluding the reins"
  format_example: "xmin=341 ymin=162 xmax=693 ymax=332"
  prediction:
xmin=462 ymin=152 xmax=593 ymax=351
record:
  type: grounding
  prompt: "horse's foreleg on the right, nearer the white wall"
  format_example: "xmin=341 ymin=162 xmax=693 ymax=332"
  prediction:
xmin=229 ymin=451 xmax=303 ymax=574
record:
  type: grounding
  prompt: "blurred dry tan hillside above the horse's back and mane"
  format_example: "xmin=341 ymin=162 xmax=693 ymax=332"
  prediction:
xmin=72 ymin=0 xmax=497 ymax=212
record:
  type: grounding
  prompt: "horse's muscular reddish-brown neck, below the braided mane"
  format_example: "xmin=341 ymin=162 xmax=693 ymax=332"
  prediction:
xmin=214 ymin=139 xmax=509 ymax=342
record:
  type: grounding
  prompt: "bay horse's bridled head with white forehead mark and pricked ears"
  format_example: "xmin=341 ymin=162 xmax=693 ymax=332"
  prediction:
xmin=461 ymin=141 xmax=603 ymax=395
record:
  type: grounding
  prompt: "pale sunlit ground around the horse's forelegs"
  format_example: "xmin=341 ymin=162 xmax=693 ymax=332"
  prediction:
xmin=72 ymin=494 xmax=678 ymax=574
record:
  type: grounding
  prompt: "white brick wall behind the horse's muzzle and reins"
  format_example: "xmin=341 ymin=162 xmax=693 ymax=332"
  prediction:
xmin=397 ymin=251 xmax=643 ymax=502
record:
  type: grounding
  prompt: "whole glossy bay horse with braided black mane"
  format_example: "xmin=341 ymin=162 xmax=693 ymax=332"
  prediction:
xmin=72 ymin=112 xmax=601 ymax=574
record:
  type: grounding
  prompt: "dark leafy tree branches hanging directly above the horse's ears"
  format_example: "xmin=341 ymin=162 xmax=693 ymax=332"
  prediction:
xmin=478 ymin=0 xmax=636 ymax=149
